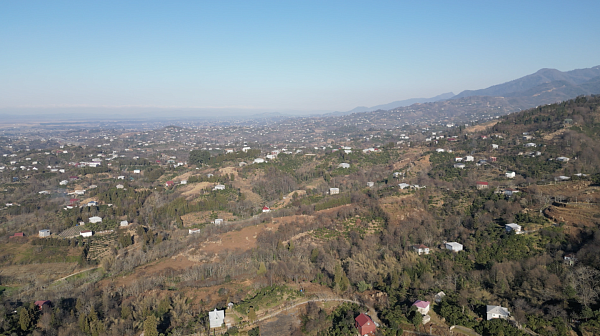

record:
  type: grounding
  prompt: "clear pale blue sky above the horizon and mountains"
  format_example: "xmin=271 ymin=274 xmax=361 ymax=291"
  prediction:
xmin=0 ymin=0 xmax=600 ymax=111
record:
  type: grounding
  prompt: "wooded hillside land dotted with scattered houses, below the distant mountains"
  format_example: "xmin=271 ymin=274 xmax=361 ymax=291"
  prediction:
xmin=0 ymin=96 xmax=600 ymax=336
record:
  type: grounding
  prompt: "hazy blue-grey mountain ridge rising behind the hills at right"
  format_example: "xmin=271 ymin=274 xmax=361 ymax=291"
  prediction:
xmin=344 ymin=66 xmax=600 ymax=115
